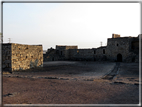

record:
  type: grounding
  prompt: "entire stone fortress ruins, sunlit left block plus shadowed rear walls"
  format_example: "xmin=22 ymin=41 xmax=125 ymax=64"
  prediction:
xmin=2 ymin=34 xmax=139 ymax=71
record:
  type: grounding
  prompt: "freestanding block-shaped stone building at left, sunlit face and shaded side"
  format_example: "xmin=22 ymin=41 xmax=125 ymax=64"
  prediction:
xmin=2 ymin=43 xmax=43 ymax=71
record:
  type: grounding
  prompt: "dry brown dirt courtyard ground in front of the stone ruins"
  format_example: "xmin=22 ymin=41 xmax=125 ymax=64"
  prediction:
xmin=3 ymin=61 xmax=140 ymax=104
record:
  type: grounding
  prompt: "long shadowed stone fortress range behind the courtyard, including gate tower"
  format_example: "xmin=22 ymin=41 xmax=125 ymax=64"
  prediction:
xmin=44 ymin=34 xmax=139 ymax=62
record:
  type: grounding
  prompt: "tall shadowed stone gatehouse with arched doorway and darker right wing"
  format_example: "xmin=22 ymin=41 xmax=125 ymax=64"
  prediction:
xmin=106 ymin=36 xmax=139 ymax=62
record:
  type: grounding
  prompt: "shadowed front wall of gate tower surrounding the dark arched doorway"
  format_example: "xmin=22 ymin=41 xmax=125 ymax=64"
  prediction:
xmin=106 ymin=37 xmax=130 ymax=61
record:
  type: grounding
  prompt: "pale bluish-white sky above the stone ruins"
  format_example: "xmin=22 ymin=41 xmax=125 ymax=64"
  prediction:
xmin=3 ymin=3 xmax=140 ymax=50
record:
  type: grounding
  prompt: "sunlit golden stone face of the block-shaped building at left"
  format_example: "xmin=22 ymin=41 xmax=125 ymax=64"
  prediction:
xmin=11 ymin=44 xmax=43 ymax=71
